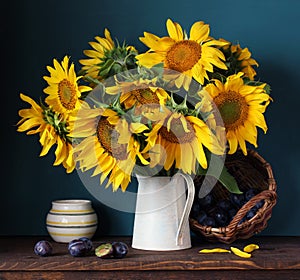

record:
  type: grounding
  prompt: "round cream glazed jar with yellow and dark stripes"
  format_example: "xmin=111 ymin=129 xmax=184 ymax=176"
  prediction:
xmin=46 ymin=199 xmax=98 ymax=243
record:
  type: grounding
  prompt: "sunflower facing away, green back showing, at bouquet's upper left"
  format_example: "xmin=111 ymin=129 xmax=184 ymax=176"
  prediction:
xmin=79 ymin=29 xmax=137 ymax=80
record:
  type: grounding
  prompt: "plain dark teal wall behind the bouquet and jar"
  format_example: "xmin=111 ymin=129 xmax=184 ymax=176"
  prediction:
xmin=0 ymin=0 xmax=300 ymax=235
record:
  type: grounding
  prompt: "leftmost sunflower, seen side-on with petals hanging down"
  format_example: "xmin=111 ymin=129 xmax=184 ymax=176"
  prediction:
xmin=17 ymin=94 xmax=75 ymax=173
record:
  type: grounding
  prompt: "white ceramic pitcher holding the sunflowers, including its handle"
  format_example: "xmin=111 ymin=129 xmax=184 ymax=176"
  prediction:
xmin=132 ymin=173 xmax=195 ymax=251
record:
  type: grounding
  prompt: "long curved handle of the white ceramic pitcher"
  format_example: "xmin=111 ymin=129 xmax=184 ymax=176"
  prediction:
xmin=174 ymin=173 xmax=195 ymax=246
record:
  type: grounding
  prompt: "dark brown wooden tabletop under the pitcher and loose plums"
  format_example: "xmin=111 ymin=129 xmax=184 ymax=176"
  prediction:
xmin=0 ymin=236 xmax=300 ymax=280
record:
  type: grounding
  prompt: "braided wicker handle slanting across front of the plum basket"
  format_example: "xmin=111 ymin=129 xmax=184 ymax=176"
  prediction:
xmin=227 ymin=190 xmax=277 ymax=229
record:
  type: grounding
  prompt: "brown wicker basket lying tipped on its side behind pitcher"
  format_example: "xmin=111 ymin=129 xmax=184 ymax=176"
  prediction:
xmin=190 ymin=150 xmax=277 ymax=244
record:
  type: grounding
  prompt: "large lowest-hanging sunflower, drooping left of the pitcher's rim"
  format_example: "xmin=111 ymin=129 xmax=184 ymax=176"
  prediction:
xmin=71 ymin=108 xmax=148 ymax=191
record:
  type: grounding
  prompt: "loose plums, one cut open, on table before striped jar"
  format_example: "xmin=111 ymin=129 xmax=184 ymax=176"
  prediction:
xmin=34 ymin=237 xmax=128 ymax=259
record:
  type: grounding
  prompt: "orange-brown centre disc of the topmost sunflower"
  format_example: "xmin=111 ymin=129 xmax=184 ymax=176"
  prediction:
xmin=166 ymin=40 xmax=201 ymax=72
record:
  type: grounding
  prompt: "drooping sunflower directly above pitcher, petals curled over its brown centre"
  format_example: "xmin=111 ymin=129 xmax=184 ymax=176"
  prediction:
xmin=143 ymin=108 xmax=223 ymax=174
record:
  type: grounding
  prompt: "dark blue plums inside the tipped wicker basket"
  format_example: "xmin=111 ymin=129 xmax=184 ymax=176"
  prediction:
xmin=191 ymin=188 xmax=264 ymax=227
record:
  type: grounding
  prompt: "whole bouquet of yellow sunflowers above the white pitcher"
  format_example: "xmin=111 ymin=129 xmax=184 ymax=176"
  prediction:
xmin=17 ymin=19 xmax=271 ymax=191
